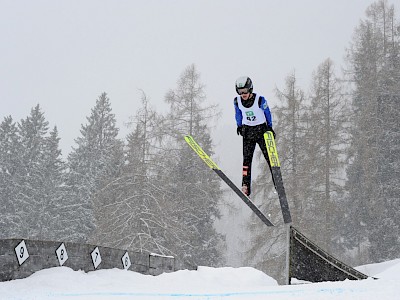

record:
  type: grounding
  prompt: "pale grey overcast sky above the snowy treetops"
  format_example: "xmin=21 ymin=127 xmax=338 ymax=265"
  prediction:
xmin=0 ymin=0 xmax=378 ymax=163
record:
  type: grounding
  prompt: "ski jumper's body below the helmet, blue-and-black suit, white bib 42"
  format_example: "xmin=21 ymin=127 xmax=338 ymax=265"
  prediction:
xmin=234 ymin=94 xmax=275 ymax=195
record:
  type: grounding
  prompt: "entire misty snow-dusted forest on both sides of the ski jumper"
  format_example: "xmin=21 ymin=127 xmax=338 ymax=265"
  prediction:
xmin=0 ymin=0 xmax=400 ymax=274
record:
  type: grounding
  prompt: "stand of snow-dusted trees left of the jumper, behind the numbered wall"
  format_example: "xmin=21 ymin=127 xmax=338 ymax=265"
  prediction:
xmin=0 ymin=65 xmax=225 ymax=266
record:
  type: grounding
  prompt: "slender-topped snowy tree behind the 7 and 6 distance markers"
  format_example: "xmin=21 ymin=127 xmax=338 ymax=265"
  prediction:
xmin=95 ymin=93 xmax=172 ymax=255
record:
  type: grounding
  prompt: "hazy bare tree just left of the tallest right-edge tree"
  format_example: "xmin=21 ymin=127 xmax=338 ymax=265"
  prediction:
xmin=306 ymin=59 xmax=350 ymax=251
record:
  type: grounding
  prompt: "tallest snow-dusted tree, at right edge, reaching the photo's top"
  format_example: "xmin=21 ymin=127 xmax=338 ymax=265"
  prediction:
xmin=347 ymin=0 xmax=400 ymax=263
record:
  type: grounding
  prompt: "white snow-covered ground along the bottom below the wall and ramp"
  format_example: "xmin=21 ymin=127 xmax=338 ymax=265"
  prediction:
xmin=0 ymin=259 xmax=400 ymax=300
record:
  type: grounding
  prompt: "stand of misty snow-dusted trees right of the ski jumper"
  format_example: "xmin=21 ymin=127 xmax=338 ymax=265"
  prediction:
xmin=248 ymin=1 xmax=400 ymax=278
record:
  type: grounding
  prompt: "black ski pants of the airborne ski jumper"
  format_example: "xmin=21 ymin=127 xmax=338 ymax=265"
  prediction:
xmin=242 ymin=124 xmax=275 ymax=195
